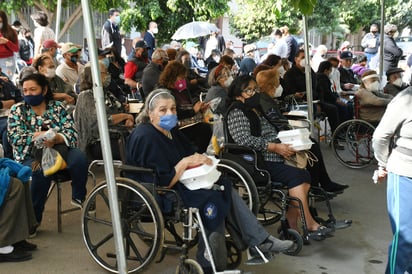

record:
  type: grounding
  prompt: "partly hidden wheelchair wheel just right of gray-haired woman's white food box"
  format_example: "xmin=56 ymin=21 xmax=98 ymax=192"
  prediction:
xmin=217 ymin=159 xmax=260 ymax=215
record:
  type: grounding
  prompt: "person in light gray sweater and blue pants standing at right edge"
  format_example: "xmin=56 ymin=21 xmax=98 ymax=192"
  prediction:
xmin=372 ymin=87 xmax=412 ymax=274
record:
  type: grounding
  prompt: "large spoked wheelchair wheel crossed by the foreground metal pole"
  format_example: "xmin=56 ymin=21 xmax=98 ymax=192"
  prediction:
xmin=82 ymin=178 xmax=164 ymax=273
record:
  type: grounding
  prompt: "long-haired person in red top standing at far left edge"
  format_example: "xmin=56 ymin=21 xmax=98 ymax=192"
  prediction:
xmin=0 ymin=10 xmax=19 ymax=79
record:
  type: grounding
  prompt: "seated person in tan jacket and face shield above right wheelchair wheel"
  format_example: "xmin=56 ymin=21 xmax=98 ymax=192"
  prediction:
xmin=355 ymin=70 xmax=393 ymax=125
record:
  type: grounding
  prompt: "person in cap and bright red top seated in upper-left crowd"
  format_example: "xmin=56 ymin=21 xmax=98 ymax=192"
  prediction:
xmin=124 ymin=40 xmax=149 ymax=93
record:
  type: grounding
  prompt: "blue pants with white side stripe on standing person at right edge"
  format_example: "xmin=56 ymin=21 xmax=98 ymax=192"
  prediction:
xmin=385 ymin=173 xmax=412 ymax=274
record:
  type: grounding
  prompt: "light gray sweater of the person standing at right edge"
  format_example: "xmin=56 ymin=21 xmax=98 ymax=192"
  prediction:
xmin=372 ymin=87 xmax=412 ymax=177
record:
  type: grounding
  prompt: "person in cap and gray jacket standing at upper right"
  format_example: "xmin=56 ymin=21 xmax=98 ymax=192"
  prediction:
xmin=383 ymin=24 xmax=403 ymax=71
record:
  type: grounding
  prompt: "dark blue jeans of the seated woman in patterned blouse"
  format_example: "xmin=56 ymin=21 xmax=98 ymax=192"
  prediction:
xmin=23 ymin=148 xmax=88 ymax=223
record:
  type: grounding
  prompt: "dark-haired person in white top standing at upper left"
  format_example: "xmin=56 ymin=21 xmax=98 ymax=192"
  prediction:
xmin=31 ymin=11 xmax=55 ymax=58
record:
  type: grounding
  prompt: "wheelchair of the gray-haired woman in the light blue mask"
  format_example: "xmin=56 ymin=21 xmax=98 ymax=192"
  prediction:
xmin=82 ymin=156 xmax=270 ymax=273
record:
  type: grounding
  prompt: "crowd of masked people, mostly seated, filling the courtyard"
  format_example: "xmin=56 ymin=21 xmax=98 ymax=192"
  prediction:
xmin=0 ymin=9 xmax=408 ymax=269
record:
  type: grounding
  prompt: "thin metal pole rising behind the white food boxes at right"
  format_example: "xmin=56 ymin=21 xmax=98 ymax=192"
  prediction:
xmin=303 ymin=15 xmax=314 ymax=132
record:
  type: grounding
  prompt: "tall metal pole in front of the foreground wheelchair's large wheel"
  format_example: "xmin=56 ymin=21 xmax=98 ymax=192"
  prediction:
xmin=82 ymin=0 xmax=127 ymax=273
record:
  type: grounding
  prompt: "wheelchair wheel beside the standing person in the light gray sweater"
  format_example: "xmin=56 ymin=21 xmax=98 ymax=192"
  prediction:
xmin=332 ymin=119 xmax=375 ymax=168
